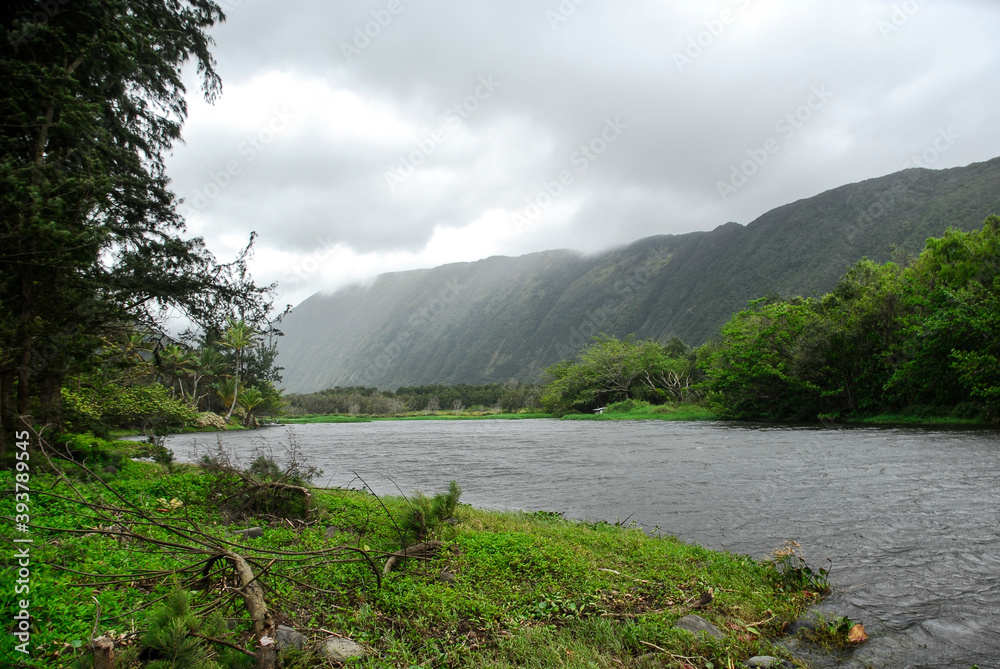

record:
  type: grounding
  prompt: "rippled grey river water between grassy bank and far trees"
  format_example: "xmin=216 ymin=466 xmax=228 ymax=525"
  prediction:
xmin=167 ymin=420 xmax=1000 ymax=669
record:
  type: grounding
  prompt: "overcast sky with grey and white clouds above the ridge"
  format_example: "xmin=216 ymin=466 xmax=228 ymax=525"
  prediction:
xmin=167 ymin=0 xmax=1000 ymax=306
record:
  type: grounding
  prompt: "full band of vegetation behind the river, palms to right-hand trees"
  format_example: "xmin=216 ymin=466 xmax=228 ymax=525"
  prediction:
xmin=41 ymin=216 xmax=1000 ymax=434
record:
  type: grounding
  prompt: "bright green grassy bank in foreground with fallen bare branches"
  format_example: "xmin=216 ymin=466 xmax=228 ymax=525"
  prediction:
xmin=0 ymin=442 xmax=821 ymax=667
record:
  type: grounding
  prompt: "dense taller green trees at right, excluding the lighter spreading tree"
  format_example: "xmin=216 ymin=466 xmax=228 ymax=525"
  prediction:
xmin=698 ymin=216 xmax=1000 ymax=421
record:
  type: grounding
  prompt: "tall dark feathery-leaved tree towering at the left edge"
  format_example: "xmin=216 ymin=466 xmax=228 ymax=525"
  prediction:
xmin=0 ymin=0 xmax=290 ymax=440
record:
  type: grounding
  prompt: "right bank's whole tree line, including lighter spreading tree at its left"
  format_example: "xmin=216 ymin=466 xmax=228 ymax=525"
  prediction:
xmin=542 ymin=216 xmax=1000 ymax=422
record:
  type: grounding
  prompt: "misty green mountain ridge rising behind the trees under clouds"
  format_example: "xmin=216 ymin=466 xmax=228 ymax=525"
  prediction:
xmin=279 ymin=158 xmax=1000 ymax=392
